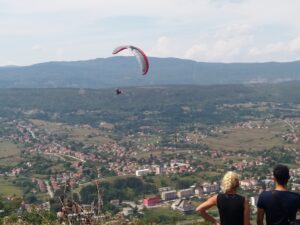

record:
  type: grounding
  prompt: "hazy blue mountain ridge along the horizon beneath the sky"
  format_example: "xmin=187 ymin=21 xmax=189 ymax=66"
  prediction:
xmin=0 ymin=57 xmax=300 ymax=88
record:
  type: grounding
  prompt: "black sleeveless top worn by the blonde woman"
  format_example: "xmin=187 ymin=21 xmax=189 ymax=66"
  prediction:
xmin=217 ymin=194 xmax=245 ymax=225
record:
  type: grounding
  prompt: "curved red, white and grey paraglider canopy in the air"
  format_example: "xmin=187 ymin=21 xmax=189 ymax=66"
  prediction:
xmin=113 ymin=45 xmax=149 ymax=75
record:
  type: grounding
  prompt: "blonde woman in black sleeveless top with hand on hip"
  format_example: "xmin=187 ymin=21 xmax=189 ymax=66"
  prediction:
xmin=196 ymin=172 xmax=250 ymax=225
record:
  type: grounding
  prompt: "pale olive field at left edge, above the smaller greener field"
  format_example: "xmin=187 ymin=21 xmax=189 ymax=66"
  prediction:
xmin=0 ymin=141 xmax=21 ymax=165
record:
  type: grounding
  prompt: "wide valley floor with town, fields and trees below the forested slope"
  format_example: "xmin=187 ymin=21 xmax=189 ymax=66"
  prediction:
xmin=0 ymin=86 xmax=300 ymax=224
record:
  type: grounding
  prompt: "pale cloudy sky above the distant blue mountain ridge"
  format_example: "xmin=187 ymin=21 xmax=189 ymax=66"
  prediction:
xmin=0 ymin=0 xmax=300 ymax=66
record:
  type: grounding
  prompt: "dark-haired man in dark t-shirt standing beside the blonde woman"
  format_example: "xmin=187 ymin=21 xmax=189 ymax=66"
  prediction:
xmin=257 ymin=165 xmax=300 ymax=225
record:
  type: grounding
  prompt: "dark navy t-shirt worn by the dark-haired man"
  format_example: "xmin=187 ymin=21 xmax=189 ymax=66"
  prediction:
xmin=257 ymin=190 xmax=300 ymax=225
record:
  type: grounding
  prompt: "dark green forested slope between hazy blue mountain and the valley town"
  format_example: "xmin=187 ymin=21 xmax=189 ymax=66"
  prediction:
xmin=0 ymin=82 xmax=300 ymax=130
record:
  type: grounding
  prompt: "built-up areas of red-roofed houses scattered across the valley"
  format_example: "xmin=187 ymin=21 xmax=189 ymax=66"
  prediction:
xmin=0 ymin=114 xmax=300 ymax=223
